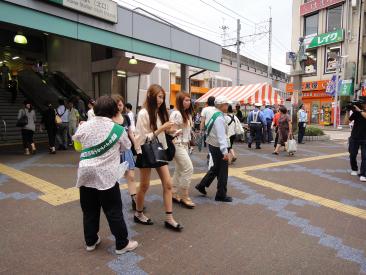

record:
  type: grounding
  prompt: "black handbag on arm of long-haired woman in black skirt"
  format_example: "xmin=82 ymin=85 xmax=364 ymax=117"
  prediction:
xmin=141 ymin=137 xmax=168 ymax=166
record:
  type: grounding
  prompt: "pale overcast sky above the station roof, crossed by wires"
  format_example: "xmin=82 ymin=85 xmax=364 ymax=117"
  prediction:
xmin=115 ymin=0 xmax=292 ymax=73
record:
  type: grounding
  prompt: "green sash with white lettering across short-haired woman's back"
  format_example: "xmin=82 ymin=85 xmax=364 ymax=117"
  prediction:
xmin=80 ymin=124 xmax=125 ymax=160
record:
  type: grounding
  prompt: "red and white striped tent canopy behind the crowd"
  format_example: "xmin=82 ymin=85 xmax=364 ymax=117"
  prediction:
xmin=196 ymin=83 xmax=284 ymax=105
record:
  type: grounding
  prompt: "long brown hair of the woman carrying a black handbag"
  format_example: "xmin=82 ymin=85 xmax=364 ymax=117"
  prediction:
xmin=144 ymin=84 xmax=169 ymax=131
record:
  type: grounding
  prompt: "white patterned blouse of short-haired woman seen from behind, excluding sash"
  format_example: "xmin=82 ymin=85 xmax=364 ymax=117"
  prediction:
xmin=72 ymin=116 xmax=131 ymax=190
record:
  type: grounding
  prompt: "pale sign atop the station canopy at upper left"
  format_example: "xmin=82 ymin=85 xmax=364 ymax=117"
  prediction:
xmin=49 ymin=0 xmax=117 ymax=23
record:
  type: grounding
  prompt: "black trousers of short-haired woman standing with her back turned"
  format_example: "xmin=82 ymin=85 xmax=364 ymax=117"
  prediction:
xmin=80 ymin=183 xmax=128 ymax=250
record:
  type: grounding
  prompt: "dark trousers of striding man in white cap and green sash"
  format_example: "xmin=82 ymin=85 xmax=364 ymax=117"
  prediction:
xmin=199 ymin=144 xmax=229 ymax=198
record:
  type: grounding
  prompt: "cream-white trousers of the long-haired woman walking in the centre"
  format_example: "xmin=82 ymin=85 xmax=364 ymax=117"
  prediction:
xmin=173 ymin=144 xmax=193 ymax=191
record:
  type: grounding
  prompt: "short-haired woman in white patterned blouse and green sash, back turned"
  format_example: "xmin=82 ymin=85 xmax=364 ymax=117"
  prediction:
xmin=73 ymin=96 xmax=138 ymax=254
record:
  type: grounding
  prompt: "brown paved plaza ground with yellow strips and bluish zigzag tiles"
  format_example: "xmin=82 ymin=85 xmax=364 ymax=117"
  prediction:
xmin=0 ymin=139 xmax=366 ymax=275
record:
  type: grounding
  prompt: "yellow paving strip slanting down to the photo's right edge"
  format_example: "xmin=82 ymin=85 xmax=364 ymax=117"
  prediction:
xmin=240 ymin=174 xmax=366 ymax=219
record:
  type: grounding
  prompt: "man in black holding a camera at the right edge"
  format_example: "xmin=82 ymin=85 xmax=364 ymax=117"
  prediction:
xmin=349 ymin=96 xmax=366 ymax=182
